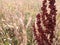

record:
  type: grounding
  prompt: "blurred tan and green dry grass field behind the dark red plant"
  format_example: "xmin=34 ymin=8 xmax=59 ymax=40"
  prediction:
xmin=0 ymin=0 xmax=60 ymax=45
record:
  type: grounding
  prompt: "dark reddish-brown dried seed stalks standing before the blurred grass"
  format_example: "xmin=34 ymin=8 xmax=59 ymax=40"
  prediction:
xmin=34 ymin=0 xmax=56 ymax=45
